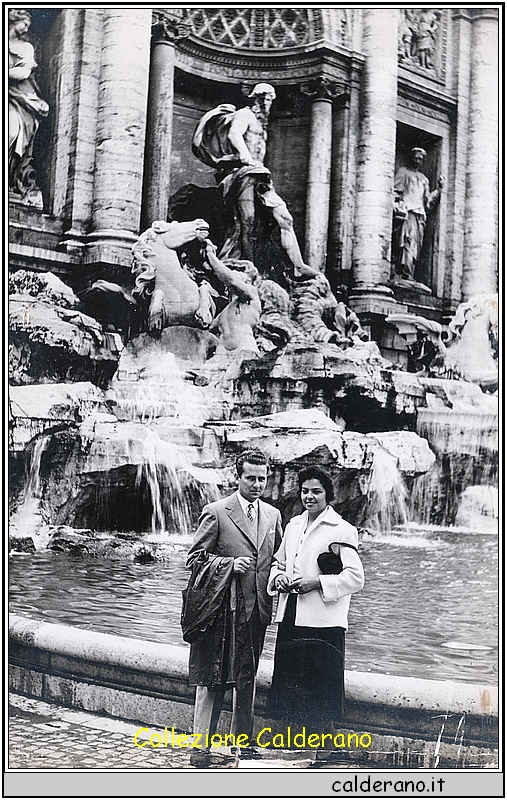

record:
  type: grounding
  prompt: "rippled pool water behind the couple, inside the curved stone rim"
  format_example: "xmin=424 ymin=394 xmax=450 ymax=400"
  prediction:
xmin=10 ymin=527 xmax=498 ymax=684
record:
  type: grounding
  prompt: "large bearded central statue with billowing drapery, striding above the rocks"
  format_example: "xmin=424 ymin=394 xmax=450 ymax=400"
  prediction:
xmin=192 ymin=83 xmax=306 ymax=277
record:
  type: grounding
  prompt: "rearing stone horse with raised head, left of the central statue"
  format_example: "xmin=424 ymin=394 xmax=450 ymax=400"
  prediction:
xmin=132 ymin=219 xmax=215 ymax=336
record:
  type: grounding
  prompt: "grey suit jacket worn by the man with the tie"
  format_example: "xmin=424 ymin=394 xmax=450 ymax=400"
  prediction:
xmin=188 ymin=492 xmax=282 ymax=625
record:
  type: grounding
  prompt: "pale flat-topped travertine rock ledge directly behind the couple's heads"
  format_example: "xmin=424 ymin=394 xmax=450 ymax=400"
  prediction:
xmin=207 ymin=409 xmax=435 ymax=525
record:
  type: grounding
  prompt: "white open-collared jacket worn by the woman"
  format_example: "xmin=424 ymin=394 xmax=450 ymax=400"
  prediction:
xmin=268 ymin=506 xmax=364 ymax=630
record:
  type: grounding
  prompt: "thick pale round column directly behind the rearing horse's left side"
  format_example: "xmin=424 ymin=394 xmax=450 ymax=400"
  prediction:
xmin=85 ymin=8 xmax=152 ymax=266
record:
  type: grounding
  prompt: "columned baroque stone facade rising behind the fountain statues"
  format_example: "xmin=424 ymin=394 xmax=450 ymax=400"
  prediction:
xmin=10 ymin=6 xmax=498 ymax=353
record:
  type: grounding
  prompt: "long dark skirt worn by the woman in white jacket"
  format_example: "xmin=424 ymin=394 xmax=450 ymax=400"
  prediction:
xmin=270 ymin=594 xmax=345 ymax=730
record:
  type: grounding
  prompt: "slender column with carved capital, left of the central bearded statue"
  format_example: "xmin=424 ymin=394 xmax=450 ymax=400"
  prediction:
xmin=142 ymin=11 xmax=189 ymax=228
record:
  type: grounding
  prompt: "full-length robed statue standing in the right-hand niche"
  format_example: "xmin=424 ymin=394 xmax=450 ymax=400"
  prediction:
xmin=392 ymin=147 xmax=445 ymax=293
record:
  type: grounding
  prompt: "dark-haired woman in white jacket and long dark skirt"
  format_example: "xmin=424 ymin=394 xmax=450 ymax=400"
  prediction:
xmin=268 ymin=467 xmax=364 ymax=732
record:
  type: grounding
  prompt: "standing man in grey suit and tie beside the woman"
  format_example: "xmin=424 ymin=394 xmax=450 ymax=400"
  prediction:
xmin=187 ymin=450 xmax=282 ymax=766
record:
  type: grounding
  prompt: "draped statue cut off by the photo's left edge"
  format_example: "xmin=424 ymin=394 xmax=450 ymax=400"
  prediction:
xmin=9 ymin=8 xmax=49 ymax=208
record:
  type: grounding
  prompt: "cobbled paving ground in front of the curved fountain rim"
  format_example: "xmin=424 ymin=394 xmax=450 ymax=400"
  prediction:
xmin=8 ymin=693 xmax=330 ymax=770
